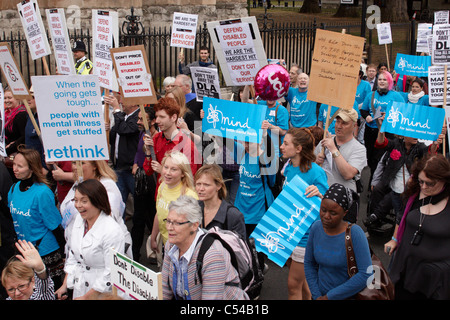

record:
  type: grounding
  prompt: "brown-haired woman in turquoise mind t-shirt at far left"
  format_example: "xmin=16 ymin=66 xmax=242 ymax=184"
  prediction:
xmin=8 ymin=145 xmax=65 ymax=288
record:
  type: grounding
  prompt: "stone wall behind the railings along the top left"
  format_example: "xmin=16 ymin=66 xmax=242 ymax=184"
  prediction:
xmin=0 ymin=0 xmax=248 ymax=37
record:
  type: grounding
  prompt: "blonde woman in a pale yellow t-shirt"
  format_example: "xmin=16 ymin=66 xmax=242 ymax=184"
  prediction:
xmin=150 ymin=150 xmax=198 ymax=252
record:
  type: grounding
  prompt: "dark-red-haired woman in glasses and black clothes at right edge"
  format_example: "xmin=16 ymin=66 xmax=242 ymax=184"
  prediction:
xmin=385 ymin=154 xmax=450 ymax=300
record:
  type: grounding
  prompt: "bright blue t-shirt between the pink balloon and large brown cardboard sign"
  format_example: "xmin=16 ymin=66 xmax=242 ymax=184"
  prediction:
xmin=286 ymin=88 xmax=317 ymax=128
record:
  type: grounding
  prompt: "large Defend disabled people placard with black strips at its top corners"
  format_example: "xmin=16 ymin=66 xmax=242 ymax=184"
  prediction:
xmin=207 ymin=16 xmax=267 ymax=86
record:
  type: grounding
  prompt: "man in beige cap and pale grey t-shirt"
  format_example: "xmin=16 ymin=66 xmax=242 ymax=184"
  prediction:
xmin=315 ymin=109 xmax=367 ymax=218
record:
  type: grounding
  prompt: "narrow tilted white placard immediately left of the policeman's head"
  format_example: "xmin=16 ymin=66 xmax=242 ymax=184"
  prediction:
xmin=45 ymin=9 xmax=76 ymax=74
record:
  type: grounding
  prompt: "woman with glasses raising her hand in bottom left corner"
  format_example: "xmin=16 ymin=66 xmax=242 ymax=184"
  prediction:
xmin=2 ymin=240 xmax=55 ymax=300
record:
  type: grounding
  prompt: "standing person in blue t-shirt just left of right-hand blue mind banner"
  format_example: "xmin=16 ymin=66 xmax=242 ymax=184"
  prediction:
xmin=360 ymin=71 xmax=405 ymax=183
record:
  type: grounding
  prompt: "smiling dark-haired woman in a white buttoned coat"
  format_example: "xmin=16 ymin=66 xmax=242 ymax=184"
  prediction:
xmin=56 ymin=179 xmax=125 ymax=300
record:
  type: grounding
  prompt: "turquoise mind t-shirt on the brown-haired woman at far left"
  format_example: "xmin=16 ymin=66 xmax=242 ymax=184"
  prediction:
xmin=8 ymin=181 xmax=62 ymax=256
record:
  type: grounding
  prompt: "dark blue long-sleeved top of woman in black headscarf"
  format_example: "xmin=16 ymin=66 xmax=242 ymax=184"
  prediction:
xmin=305 ymin=220 xmax=372 ymax=300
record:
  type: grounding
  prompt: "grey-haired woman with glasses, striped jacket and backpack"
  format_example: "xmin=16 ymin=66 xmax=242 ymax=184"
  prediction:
xmin=162 ymin=195 xmax=248 ymax=300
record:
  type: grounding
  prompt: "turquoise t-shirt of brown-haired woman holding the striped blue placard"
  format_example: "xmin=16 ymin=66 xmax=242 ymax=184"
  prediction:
xmin=283 ymin=162 xmax=329 ymax=248
